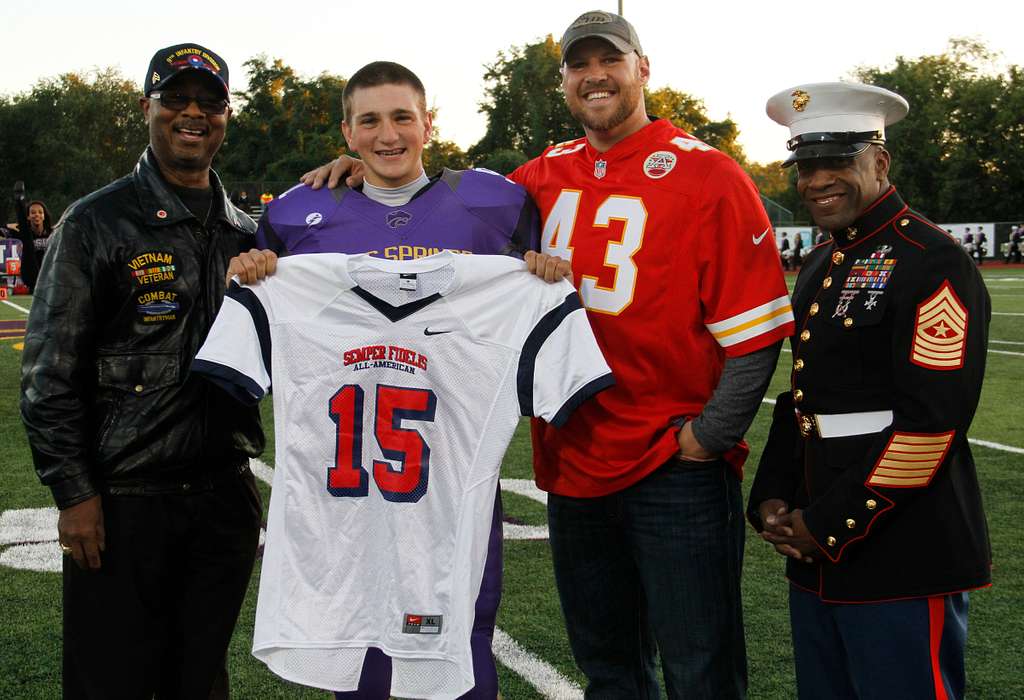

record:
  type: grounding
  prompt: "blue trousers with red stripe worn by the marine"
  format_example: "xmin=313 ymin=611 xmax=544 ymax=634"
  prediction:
xmin=790 ymin=585 xmax=968 ymax=700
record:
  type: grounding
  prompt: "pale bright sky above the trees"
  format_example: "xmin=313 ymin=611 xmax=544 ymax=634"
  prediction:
xmin=0 ymin=0 xmax=1024 ymax=163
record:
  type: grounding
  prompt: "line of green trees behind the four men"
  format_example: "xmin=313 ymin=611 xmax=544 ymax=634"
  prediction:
xmin=0 ymin=36 xmax=1024 ymax=221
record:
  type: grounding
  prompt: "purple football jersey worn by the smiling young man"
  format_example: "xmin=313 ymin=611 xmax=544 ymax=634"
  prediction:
xmin=256 ymin=170 xmax=538 ymax=260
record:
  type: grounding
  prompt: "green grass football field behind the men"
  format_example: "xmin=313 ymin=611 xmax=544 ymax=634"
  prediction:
xmin=0 ymin=264 xmax=1024 ymax=700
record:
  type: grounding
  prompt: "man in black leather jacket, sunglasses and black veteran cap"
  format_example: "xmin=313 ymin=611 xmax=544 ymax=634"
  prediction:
xmin=22 ymin=44 xmax=264 ymax=698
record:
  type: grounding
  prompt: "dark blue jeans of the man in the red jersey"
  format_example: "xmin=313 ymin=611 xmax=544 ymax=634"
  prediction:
xmin=548 ymin=458 xmax=746 ymax=700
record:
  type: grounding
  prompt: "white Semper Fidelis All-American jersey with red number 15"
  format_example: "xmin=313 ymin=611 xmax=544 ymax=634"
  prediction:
xmin=194 ymin=253 xmax=612 ymax=698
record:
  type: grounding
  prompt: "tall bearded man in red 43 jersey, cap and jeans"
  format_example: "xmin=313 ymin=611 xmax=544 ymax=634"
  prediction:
xmin=304 ymin=11 xmax=794 ymax=700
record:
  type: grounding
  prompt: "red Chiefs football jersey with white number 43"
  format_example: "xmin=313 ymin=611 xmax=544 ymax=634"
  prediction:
xmin=510 ymin=120 xmax=794 ymax=497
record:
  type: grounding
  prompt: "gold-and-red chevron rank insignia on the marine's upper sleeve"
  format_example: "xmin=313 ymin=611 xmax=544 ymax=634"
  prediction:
xmin=910 ymin=280 xmax=968 ymax=370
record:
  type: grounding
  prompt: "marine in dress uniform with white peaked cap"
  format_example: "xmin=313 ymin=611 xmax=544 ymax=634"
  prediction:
xmin=748 ymin=83 xmax=991 ymax=698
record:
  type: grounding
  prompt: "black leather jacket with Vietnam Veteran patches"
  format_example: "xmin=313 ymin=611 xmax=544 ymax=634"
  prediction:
xmin=22 ymin=150 xmax=264 ymax=509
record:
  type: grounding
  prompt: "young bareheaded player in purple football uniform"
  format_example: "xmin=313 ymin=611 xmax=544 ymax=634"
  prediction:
xmin=228 ymin=61 xmax=539 ymax=700
